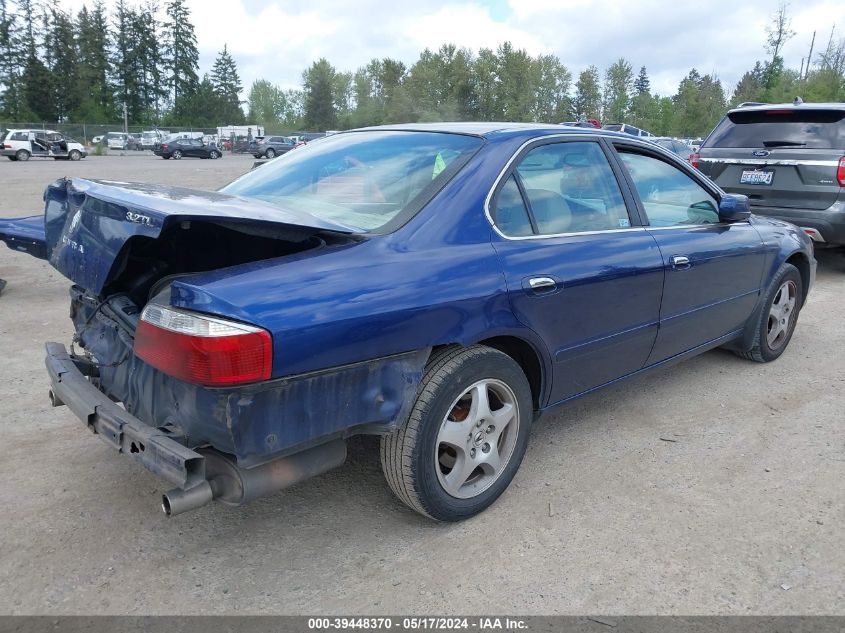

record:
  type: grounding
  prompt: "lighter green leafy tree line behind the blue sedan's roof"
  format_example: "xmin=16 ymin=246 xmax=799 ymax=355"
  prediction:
xmin=247 ymin=5 xmax=845 ymax=137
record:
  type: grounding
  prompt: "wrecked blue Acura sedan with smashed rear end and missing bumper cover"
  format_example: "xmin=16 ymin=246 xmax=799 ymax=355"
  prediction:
xmin=0 ymin=123 xmax=816 ymax=521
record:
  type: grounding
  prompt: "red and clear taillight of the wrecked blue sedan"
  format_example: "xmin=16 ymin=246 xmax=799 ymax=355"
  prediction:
xmin=135 ymin=304 xmax=273 ymax=387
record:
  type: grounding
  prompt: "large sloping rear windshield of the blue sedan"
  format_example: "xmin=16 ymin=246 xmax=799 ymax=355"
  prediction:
xmin=221 ymin=130 xmax=483 ymax=231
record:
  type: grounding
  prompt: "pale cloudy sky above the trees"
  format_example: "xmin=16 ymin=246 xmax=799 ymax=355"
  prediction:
xmin=59 ymin=0 xmax=845 ymax=95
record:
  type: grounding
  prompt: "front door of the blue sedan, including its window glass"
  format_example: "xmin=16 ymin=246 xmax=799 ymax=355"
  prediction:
xmin=615 ymin=142 xmax=766 ymax=364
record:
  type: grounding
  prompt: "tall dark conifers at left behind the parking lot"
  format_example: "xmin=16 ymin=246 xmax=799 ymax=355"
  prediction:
xmin=0 ymin=0 xmax=244 ymax=127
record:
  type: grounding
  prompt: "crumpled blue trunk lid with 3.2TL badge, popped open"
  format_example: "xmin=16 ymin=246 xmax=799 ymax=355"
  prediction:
xmin=28 ymin=178 xmax=352 ymax=295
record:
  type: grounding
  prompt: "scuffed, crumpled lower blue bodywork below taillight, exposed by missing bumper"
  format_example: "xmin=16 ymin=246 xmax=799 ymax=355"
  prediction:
xmin=71 ymin=288 xmax=430 ymax=467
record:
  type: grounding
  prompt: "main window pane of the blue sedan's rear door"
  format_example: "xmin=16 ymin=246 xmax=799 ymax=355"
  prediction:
xmin=516 ymin=142 xmax=631 ymax=235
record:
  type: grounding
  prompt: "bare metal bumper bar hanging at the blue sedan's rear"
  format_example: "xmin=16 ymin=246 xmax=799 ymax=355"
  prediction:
xmin=45 ymin=343 xmax=206 ymax=490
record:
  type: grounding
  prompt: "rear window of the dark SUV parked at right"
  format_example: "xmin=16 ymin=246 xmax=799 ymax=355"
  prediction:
xmin=702 ymin=110 xmax=845 ymax=149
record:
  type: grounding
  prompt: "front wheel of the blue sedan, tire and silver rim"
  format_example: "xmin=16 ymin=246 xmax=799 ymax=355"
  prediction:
xmin=736 ymin=264 xmax=804 ymax=363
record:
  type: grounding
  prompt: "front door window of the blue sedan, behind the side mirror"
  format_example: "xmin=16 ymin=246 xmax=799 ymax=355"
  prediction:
xmin=619 ymin=151 xmax=719 ymax=226
